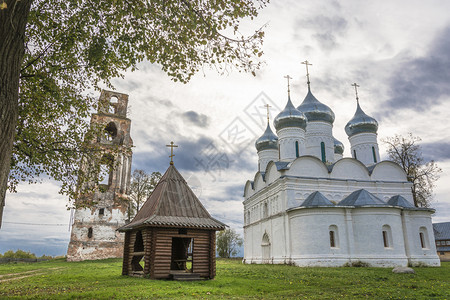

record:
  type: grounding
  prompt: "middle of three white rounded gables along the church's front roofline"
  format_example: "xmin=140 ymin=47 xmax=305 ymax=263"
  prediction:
xmin=330 ymin=157 xmax=370 ymax=180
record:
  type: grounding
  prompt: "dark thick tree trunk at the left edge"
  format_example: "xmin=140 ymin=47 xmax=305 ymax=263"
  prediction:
xmin=0 ymin=0 xmax=32 ymax=227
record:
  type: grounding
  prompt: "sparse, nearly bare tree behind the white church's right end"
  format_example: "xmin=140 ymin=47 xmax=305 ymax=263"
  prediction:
xmin=383 ymin=133 xmax=442 ymax=207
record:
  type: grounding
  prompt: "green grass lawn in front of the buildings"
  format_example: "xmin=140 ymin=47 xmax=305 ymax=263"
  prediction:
xmin=0 ymin=259 xmax=450 ymax=299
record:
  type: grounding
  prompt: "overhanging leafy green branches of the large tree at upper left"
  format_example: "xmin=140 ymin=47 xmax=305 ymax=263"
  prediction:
xmin=6 ymin=0 xmax=267 ymax=204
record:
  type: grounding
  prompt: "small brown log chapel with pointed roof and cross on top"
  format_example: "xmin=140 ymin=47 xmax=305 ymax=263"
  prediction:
xmin=118 ymin=143 xmax=226 ymax=280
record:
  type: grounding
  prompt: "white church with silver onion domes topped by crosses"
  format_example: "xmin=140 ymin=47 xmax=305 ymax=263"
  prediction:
xmin=243 ymin=68 xmax=440 ymax=267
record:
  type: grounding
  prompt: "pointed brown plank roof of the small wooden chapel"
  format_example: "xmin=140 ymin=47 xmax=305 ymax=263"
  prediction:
xmin=118 ymin=165 xmax=226 ymax=231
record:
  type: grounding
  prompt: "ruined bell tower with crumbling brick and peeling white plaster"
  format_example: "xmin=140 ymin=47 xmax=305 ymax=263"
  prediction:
xmin=67 ymin=90 xmax=133 ymax=261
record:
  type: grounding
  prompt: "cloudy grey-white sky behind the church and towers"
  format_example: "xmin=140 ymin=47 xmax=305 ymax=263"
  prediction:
xmin=0 ymin=0 xmax=450 ymax=255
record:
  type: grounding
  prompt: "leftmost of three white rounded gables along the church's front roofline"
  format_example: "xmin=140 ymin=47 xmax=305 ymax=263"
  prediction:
xmin=286 ymin=155 xmax=329 ymax=178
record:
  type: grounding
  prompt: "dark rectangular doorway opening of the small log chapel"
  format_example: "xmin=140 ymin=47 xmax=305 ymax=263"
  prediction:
xmin=170 ymin=237 xmax=194 ymax=272
